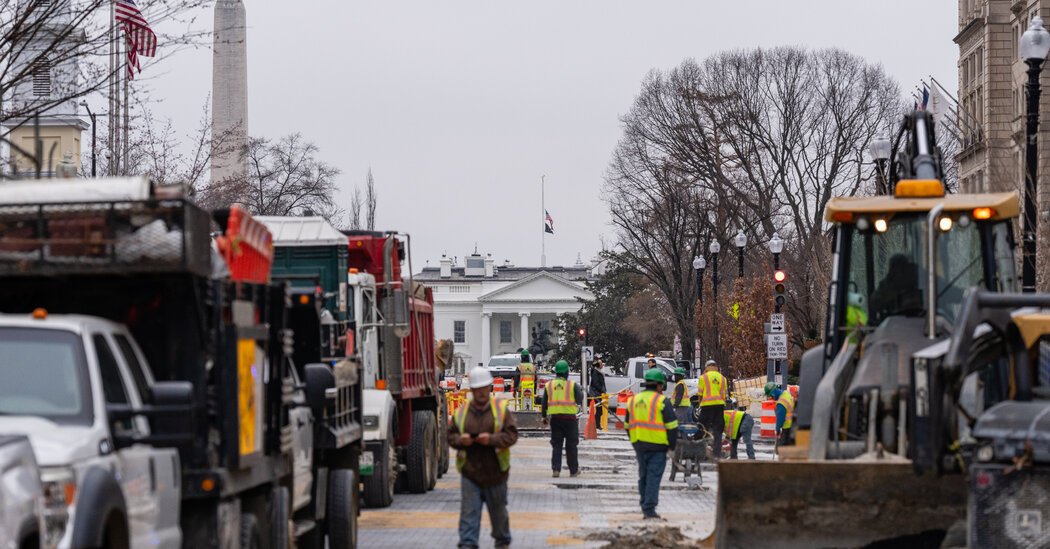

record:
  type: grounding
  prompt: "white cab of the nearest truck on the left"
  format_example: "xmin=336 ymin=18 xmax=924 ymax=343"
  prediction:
xmin=0 ymin=310 xmax=191 ymax=548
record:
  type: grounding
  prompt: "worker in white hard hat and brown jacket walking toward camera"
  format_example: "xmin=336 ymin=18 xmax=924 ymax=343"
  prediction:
xmin=448 ymin=367 xmax=518 ymax=548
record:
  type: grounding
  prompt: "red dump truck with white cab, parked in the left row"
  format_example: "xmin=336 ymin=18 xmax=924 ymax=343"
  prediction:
xmin=345 ymin=231 xmax=449 ymax=507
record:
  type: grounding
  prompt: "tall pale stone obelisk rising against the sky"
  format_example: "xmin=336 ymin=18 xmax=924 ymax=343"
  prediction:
xmin=211 ymin=0 xmax=248 ymax=183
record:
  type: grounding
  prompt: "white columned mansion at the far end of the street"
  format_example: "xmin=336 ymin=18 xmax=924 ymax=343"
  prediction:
xmin=415 ymin=251 xmax=603 ymax=369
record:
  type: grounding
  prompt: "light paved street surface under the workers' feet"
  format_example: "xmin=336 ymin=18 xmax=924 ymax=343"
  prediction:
xmin=360 ymin=424 xmax=773 ymax=549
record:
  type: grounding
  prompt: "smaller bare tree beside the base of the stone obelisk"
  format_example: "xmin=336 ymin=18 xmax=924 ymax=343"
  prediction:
xmin=201 ymin=133 xmax=342 ymax=219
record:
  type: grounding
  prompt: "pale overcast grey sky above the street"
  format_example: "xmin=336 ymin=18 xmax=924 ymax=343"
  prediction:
xmin=137 ymin=0 xmax=959 ymax=271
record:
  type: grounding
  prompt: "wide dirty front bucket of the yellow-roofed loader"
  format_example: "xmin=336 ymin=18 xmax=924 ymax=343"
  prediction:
xmin=714 ymin=461 xmax=966 ymax=548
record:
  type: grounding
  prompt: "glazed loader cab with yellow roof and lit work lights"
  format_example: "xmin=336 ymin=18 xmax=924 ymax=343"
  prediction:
xmin=826 ymin=182 xmax=1019 ymax=357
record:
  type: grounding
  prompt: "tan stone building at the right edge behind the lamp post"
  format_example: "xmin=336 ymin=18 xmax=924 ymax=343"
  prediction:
xmin=954 ymin=0 xmax=1050 ymax=291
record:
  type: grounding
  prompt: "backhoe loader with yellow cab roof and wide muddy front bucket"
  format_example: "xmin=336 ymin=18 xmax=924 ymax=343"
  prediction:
xmin=715 ymin=112 xmax=1020 ymax=547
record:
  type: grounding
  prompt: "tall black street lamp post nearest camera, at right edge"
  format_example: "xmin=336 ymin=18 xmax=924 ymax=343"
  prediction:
xmin=1021 ymin=16 xmax=1050 ymax=292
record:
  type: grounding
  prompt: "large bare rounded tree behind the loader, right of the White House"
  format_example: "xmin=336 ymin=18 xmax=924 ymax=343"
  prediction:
xmin=606 ymin=48 xmax=901 ymax=365
